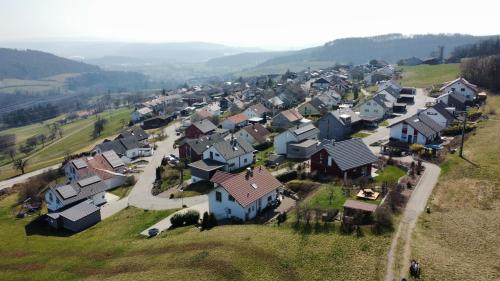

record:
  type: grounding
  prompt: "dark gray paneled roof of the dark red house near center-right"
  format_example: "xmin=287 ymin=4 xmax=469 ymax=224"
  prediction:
xmin=320 ymin=138 xmax=378 ymax=171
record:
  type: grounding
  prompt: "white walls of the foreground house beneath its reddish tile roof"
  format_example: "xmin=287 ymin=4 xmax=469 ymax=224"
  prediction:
xmin=208 ymin=187 xmax=277 ymax=221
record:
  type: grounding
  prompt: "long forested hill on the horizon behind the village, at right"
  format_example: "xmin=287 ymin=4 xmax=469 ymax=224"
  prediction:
xmin=261 ymin=34 xmax=496 ymax=66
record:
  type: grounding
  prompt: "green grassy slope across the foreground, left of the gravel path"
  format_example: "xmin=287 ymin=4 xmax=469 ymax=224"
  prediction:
xmin=0 ymin=189 xmax=390 ymax=281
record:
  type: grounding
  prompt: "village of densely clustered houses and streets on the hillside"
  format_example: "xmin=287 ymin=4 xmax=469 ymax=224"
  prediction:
xmin=36 ymin=62 xmax=485 ymax=235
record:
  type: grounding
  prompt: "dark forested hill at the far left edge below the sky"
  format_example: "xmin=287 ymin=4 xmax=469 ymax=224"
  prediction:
xmin=0 ymin=48 xmax=100 ymax=79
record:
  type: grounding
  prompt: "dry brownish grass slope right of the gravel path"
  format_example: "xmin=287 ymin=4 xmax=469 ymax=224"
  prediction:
xmin=412 ymin=95 xmax=500 ymax=280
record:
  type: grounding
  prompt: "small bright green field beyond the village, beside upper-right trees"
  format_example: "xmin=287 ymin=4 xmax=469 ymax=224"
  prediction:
xmin=400 ymin=64 xmax=460 ymax=88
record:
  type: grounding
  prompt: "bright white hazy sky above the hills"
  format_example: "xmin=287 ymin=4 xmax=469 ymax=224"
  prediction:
xmin=0 ymin=0 xmax=500 ymax=49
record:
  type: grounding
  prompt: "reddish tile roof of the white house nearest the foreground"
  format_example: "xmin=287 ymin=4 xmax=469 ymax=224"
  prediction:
xmin=211 ymin=167 xmax=283 ymax=208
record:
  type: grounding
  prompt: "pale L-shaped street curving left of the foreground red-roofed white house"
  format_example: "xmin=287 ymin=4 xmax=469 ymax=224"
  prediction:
xmin=128 ymin=122 xmax=208 ymax=210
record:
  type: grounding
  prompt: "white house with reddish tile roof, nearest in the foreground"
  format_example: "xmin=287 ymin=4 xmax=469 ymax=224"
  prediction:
xmin=208 ymin=167 xmax=283 ymax=221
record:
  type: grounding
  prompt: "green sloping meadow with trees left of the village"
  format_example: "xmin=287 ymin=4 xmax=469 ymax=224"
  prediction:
xmin=0 ymin=108 xmax=132 ymax=179
